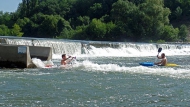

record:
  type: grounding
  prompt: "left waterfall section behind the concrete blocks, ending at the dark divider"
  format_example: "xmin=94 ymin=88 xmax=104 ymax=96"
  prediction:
xmin=0 ymin=37 xmax=81 ymax=54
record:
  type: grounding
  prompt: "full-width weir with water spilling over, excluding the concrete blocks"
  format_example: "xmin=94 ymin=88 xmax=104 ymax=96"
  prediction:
xmin=0 ymin=36 xmax=190 ymax=59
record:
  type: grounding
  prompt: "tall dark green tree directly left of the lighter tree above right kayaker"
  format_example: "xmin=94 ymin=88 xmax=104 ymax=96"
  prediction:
xmin=111 ymin=0 xmax=138 ymax=39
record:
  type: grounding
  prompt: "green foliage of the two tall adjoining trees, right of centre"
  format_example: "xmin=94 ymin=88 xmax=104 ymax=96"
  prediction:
xmin=111 ymin=0 xmax=174 ymax=41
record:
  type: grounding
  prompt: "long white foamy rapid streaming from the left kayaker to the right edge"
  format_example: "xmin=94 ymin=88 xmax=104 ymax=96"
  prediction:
xmin=73 ymin=60 xmax=190 ymax=78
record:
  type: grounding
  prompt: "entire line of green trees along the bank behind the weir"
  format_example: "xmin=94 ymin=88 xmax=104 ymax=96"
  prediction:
xmin=0 ymin=0 xmax=190 ymax=42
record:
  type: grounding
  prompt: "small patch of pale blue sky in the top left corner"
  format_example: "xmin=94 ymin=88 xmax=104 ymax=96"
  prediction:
xmin=0 ymin=0 xmax=22 ymax=12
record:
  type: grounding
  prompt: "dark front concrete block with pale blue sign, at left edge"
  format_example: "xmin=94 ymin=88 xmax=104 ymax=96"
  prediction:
xmin=0 ymin=45 xmax=32 ymax=68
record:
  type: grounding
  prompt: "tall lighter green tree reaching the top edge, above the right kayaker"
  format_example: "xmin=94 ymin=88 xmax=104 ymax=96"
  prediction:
xmin=139 ymin=0 xmax=170 ymax=40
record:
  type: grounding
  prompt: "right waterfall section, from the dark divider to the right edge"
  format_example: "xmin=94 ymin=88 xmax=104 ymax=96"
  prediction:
xmin=82 ymin=41 xmax=190 ymax=57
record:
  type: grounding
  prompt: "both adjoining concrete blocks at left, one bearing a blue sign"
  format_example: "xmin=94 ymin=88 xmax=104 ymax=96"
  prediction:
xmin=0 ymin=44 xmax=52 ymax=68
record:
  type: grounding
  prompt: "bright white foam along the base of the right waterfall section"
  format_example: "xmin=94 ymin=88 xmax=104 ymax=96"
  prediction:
xmin=81 ymin=46 xmax=190 ymax=57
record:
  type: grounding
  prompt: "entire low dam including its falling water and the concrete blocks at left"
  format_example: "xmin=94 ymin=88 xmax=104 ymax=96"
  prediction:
xmin=0 ymin=36 xmax=189 ymax=68
